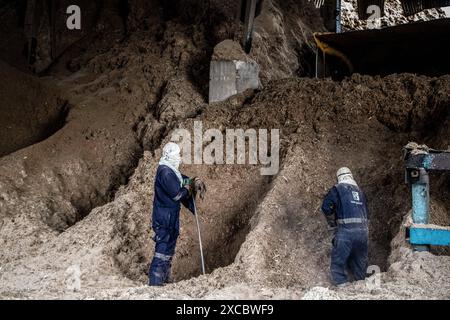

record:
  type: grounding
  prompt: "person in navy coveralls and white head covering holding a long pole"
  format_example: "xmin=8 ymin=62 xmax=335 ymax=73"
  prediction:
xmin=148 ymin=142 xmax=204 ymax=286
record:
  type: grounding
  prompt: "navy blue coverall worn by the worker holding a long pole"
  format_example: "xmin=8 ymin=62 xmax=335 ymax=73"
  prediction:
xmin=148 ymin=165 xmax=194 ymax=286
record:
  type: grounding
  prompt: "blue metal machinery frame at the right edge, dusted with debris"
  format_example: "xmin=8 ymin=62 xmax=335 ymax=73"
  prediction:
xmin=405 ymin=144 xmax=450 ymax=251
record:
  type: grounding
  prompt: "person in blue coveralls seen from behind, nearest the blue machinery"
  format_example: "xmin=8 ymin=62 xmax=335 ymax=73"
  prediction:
xmin=322 ymin=167 xmax=369 ymax=287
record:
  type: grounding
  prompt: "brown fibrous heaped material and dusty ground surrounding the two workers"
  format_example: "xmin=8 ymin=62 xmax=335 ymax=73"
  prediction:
xmin=0 ymin=1 xmax=450 ymax=299
